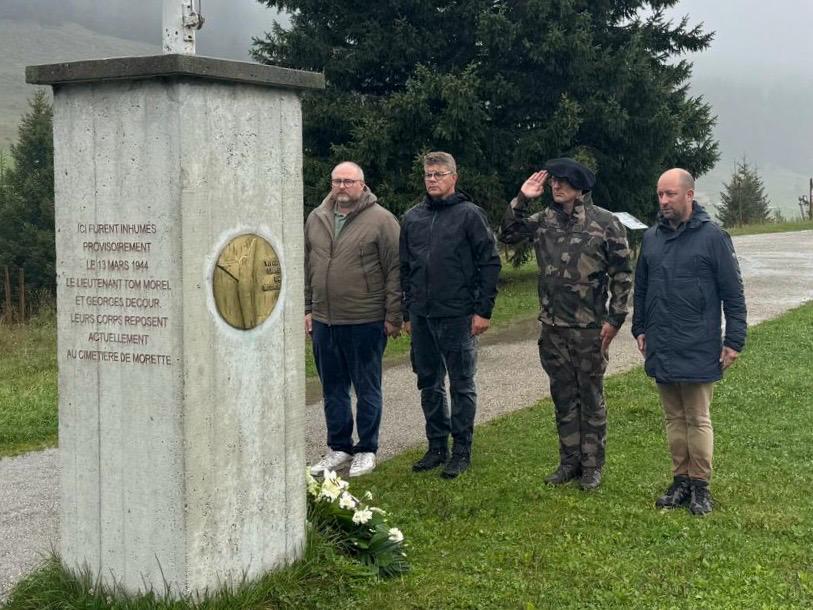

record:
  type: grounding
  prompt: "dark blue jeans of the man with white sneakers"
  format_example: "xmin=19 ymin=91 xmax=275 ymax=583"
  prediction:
xmin=311 ymin=320 xmax=387 ymax=453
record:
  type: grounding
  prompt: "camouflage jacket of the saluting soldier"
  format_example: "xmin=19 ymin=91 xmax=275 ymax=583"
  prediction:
xmin=500 ymin=193 xmax=632 ymax=328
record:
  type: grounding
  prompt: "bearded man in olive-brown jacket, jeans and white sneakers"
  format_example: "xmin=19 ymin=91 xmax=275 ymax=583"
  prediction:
xmin=305 ymin=161 xmax=402 ymax=477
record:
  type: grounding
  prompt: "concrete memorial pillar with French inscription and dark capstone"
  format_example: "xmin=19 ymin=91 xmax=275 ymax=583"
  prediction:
xmin=26 ymin=54 xmax=324 ymax=594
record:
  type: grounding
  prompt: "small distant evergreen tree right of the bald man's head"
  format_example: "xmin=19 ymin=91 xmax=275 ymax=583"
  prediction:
xmin=717 ymin=160 xmax=771 ymax=227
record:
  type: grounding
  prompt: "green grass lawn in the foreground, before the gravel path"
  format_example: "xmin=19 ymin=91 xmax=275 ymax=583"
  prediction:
xmin=7 ymin=303 xmax=813 ymax=610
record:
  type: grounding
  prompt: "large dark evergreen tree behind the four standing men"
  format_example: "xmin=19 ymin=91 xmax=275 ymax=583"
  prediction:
xmin=253 ymin=0 xmax=718 ymax=222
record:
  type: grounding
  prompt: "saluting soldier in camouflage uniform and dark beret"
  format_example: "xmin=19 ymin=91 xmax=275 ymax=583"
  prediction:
xmin=500 ymin=159 xmax=632 ymax=489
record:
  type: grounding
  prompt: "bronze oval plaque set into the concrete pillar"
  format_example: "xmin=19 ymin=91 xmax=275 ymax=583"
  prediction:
xmin=212 ymin=234 xmax=282 ymax=330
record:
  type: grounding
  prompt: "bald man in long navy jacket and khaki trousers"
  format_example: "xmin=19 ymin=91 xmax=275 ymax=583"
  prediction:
xmin=632 ymin=168 xmax=746 ymax=515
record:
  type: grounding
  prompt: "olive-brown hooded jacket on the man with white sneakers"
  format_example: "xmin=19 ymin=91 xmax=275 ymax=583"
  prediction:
xmin=305 ymin=190 xmax=401 ymax=326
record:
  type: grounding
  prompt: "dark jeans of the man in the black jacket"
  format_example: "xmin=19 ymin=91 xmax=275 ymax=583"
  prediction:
xmin=410 ymin=315 xmax=477 ymax=453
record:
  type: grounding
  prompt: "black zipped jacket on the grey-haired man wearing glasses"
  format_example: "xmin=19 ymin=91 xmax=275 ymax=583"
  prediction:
xmin=401 ymin=191 xmax=500 ymax=320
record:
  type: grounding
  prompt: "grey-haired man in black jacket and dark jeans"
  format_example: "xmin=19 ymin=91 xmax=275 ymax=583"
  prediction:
xmin=400 ymin=152 xmax=500 ymax=479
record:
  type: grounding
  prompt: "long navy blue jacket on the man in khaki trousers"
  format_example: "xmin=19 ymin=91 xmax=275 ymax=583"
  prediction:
xmin=632 ymin=201 xmax=747 ymax=383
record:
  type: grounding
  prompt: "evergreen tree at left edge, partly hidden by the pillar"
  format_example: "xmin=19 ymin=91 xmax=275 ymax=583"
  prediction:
xmin=0 ymin=90 xmax=56 ymax=302
